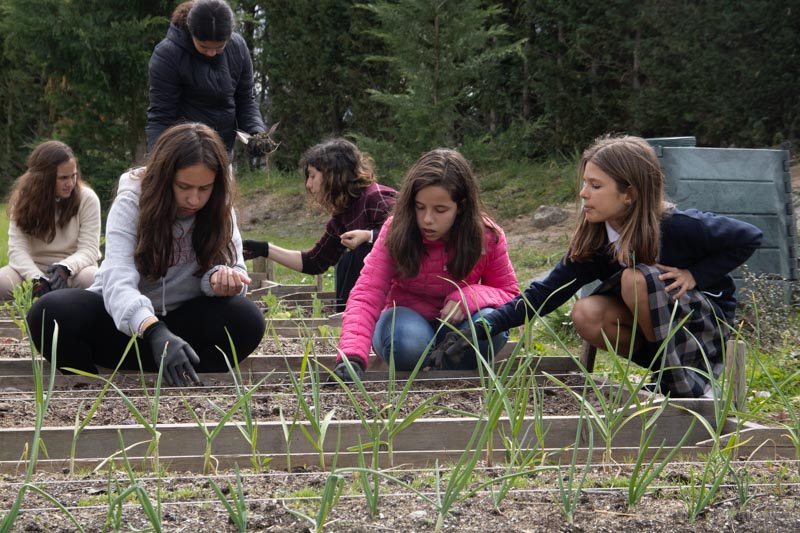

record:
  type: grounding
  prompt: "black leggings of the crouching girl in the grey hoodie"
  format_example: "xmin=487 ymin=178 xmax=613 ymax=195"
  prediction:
xmin=27 ymin=289 xmax=266 ymax=373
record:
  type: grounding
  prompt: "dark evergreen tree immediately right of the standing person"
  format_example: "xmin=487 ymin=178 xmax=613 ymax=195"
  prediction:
xmin=255 ymin=0 xmax=382 ymax=167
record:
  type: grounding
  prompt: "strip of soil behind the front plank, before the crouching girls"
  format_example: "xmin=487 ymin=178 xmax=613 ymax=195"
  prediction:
xmin=0 ymin=362 xmax=598 ymax=428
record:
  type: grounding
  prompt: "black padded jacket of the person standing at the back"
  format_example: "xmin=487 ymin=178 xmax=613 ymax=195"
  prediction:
xmin=146 ymin=24 xmax=266 ymax=152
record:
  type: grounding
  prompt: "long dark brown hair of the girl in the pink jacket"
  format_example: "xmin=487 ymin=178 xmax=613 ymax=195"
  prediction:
xmin=386 ymin=148 xmax=498 ymax=280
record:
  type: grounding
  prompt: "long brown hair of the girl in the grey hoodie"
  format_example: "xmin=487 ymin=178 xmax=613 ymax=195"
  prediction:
xmin=134 ymin=123 xmax=236 ymax=279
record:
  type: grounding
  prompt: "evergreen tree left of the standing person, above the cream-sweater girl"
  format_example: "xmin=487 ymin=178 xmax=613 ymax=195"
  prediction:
xmin=2 ymin=0 xmax=172 ymax=200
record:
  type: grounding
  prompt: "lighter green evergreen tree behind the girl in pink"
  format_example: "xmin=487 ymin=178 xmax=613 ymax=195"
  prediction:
xmin=366 ymin=0 xmax=521 ymax=164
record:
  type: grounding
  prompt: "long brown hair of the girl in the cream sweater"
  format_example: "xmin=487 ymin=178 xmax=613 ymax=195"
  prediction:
xmin=6 ymin=141 xmax=86 ymax=242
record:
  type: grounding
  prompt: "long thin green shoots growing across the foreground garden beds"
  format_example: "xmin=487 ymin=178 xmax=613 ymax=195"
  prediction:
xmin=0 ymin=284 xmax=800 ymax=532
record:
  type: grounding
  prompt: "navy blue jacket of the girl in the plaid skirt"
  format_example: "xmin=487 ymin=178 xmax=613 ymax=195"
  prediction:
xmin=486 ymin=209 xmax=762 ymax=331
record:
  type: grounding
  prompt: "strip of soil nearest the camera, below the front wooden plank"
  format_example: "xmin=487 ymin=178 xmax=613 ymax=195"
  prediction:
xmin=0 ymin=463 xmax=800 ymax=533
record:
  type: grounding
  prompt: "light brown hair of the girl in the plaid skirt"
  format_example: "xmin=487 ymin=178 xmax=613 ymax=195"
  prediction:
xmin=567 ymin=135 xmax=673 ymax=265
